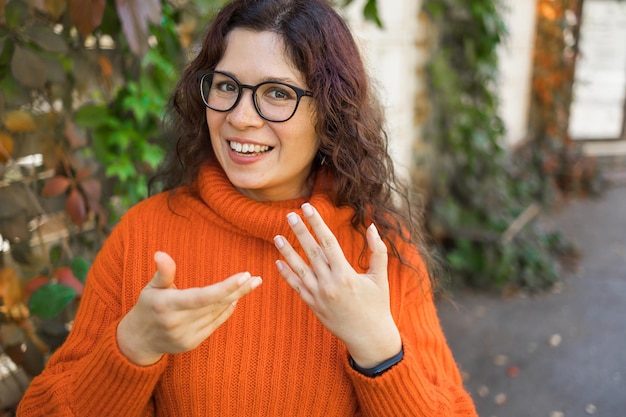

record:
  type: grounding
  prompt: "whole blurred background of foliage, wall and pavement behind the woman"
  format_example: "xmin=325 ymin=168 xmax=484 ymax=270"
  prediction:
xmin=0 ymin=0 xmax=626 ymax=417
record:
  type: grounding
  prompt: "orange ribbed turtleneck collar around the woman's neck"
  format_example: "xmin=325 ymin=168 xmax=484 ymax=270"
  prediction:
xmin=197 ymin=163 xmax=353 ymax=241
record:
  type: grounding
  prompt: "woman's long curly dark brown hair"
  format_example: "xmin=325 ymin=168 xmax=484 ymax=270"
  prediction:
xmin=156 ymin=0 xmax=432 ymax=282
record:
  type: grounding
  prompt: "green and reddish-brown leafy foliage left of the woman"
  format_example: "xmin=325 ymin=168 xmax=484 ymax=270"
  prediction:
xmin=0 ymin=0 xmax=221 ymax=386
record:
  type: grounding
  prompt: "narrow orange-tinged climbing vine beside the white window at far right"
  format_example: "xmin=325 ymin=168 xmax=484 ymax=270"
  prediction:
xmin=517 ymin=0 xmax=605 ymax=204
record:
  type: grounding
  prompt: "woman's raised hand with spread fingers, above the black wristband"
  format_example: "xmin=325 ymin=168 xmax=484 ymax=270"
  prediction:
xmin=274 ymin=203 xmax=402 ymax=368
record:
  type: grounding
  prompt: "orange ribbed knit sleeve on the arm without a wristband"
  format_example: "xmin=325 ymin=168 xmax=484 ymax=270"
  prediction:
xmin=18 ymin=219 xmax=167 ymax=417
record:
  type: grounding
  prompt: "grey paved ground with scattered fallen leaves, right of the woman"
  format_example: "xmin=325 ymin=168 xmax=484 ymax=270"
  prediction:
xmin=439 ymin=183 xmax=626 ymax=417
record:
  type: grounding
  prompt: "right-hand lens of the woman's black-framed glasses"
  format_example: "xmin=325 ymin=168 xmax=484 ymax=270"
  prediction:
xmin=254 ymin=83 xmax=298 ymax=122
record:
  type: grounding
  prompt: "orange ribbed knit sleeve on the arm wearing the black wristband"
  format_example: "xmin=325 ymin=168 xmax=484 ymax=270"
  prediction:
xmin=344 ymin=247 xmax=477 ymax=417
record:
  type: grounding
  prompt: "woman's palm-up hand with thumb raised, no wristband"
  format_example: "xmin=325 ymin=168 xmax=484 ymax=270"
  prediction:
xmin=117 ymin=252 xmax=261 ymax=366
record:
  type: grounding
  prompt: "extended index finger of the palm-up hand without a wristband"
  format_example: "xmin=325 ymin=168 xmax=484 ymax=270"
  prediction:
xmin=170 ymin=272 xmax=263 ymax=310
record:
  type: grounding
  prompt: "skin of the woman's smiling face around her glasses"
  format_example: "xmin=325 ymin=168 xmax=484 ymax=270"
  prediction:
xmin=206 ymin=29 xmax=318 ymax=201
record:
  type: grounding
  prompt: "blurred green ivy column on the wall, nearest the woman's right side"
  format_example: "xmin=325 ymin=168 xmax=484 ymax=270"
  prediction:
xmin=424 ymin=0 xmax=568 ymax=290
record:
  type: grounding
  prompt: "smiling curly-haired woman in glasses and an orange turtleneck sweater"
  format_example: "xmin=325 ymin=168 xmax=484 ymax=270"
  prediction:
xmin=19 ymin=0 xmax=475 ymax=416
